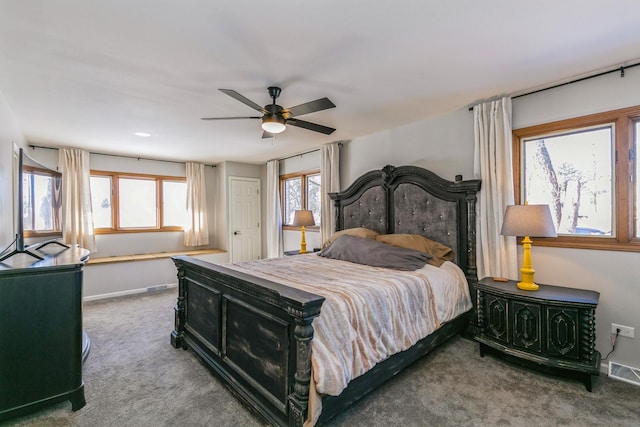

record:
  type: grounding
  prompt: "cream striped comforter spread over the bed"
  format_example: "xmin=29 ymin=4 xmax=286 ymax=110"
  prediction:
xmin=227 ymin=254 xmax=471 ymax=396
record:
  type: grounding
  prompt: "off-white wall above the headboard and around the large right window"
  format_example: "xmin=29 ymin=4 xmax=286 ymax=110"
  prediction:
xmin=340 ymin=69 xmax=640 ymax=367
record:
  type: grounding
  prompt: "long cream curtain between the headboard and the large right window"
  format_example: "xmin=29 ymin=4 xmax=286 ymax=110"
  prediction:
xmin=473 ymin=97 xmax=518 ymax=279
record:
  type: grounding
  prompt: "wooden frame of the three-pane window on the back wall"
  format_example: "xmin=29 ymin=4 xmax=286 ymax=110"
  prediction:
xmin=90 ymin=169 xmax=187 ymax=234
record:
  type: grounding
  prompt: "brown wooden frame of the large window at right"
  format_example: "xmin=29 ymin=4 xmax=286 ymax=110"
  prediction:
xmin=512 ymin=106 xmax=640 ymax=252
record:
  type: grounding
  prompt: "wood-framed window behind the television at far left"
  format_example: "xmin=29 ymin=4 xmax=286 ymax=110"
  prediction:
xmin=22 ymin=166 xmax=62 ymax=237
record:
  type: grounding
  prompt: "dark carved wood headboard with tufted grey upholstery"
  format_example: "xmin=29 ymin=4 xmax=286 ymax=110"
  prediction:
xmin=329 ymin=165 xmax=480 ymax=279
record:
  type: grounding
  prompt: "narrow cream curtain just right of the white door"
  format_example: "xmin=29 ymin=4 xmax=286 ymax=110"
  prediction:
xmin=266 ymin=160 xmax=283 ymax=258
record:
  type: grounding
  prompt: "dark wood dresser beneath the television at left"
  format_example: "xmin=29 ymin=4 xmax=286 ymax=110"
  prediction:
xmin=0 ymin=248 xmax=89 ymax=421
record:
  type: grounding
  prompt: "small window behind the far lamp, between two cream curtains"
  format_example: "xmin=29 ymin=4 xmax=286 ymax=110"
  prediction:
xmin=280 ymin=171 xmax=321 ymax=226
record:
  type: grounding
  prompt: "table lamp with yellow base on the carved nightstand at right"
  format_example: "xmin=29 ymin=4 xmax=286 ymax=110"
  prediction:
xmin=500 ymin=204 xmax=556 ymax=291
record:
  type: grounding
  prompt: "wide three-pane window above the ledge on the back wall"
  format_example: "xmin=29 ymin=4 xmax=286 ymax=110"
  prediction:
xmin=91 ymin=171 xmax=187 ymax=233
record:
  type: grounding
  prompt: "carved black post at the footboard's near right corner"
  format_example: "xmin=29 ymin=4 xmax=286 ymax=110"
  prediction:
xmin=289 ymin=316 xmax=315 ymax=427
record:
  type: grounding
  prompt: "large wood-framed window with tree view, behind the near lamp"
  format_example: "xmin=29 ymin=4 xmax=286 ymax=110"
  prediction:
xmin=513 ymin=107 xmax=640 ymax=251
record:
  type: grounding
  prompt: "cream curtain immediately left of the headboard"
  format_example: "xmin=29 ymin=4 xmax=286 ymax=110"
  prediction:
xmin=320 ymin=142 xmax=340 ymax=245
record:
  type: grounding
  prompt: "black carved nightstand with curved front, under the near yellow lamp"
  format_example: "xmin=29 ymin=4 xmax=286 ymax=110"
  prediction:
xmin=474 ymin=278 xmax=600 ymax=391
